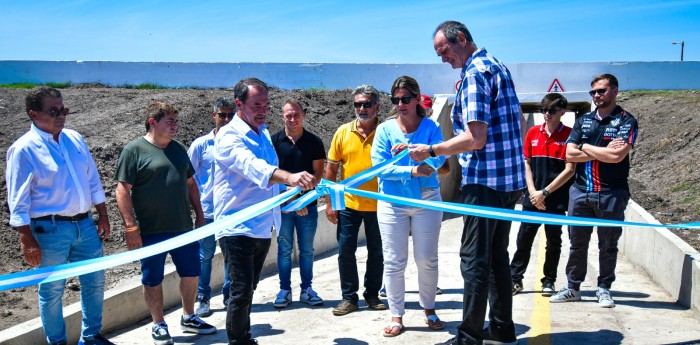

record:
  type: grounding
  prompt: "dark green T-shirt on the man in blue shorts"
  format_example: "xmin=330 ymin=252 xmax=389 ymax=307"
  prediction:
xmin=115 ymin=137 xmax=194 ymax=235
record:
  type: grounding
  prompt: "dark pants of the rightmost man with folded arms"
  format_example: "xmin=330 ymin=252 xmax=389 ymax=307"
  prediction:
xmin=566 ymin=186 xmax=630 ymax=290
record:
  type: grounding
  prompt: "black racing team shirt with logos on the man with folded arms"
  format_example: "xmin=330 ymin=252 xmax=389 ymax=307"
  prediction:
xmin=566 ymin=105 xmax=638 ymax=192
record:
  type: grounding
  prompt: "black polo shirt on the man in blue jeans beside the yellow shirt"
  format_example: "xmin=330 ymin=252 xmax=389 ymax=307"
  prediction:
xmin=271 ymin=129 xmax=326 ymax=206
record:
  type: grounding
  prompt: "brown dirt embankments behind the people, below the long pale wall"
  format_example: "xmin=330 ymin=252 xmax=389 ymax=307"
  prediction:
xmin=0 ymin=84 xmax=700 ymax=329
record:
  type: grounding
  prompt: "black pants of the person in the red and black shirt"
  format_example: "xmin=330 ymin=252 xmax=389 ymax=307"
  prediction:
xmin=510 ymin=206 xmax=566 ymax=283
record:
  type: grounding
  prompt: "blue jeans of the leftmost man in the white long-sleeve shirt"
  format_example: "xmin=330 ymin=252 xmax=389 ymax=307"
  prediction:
xmin=30 ymin=217 xmax=105 ymax=344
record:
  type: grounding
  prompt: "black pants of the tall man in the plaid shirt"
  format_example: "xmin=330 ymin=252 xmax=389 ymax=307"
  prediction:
xmin=457 ymin=184 xmax=522 ymax=344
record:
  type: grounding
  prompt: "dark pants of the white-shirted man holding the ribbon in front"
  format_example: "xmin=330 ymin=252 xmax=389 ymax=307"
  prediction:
xmin=219 ymin=236 xmax=271 ymax=344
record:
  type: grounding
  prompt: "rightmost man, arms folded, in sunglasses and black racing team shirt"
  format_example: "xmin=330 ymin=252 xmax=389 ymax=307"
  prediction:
xmin=549 ymin=74 xmax=638 ymax=308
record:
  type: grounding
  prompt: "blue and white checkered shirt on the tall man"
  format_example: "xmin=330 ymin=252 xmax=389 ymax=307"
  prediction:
xmin=452 ymin=48 xmax=526 ymax=192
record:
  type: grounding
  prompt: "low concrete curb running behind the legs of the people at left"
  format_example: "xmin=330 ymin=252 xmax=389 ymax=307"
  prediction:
xmin=0 ymin=207 xmax=365 ymax=345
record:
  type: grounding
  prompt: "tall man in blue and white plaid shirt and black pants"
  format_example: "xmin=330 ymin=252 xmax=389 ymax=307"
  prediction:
xmin=410 ymin=21 xmax=526 ymax=344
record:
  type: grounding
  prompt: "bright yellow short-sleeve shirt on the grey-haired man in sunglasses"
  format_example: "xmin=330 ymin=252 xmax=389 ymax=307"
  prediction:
xmin=328 ymin=120 xmax=379 ymax=212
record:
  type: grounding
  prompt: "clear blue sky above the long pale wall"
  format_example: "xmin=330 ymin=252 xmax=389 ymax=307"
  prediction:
xmin=0 ymin=0 xmax=700 ymax=63
